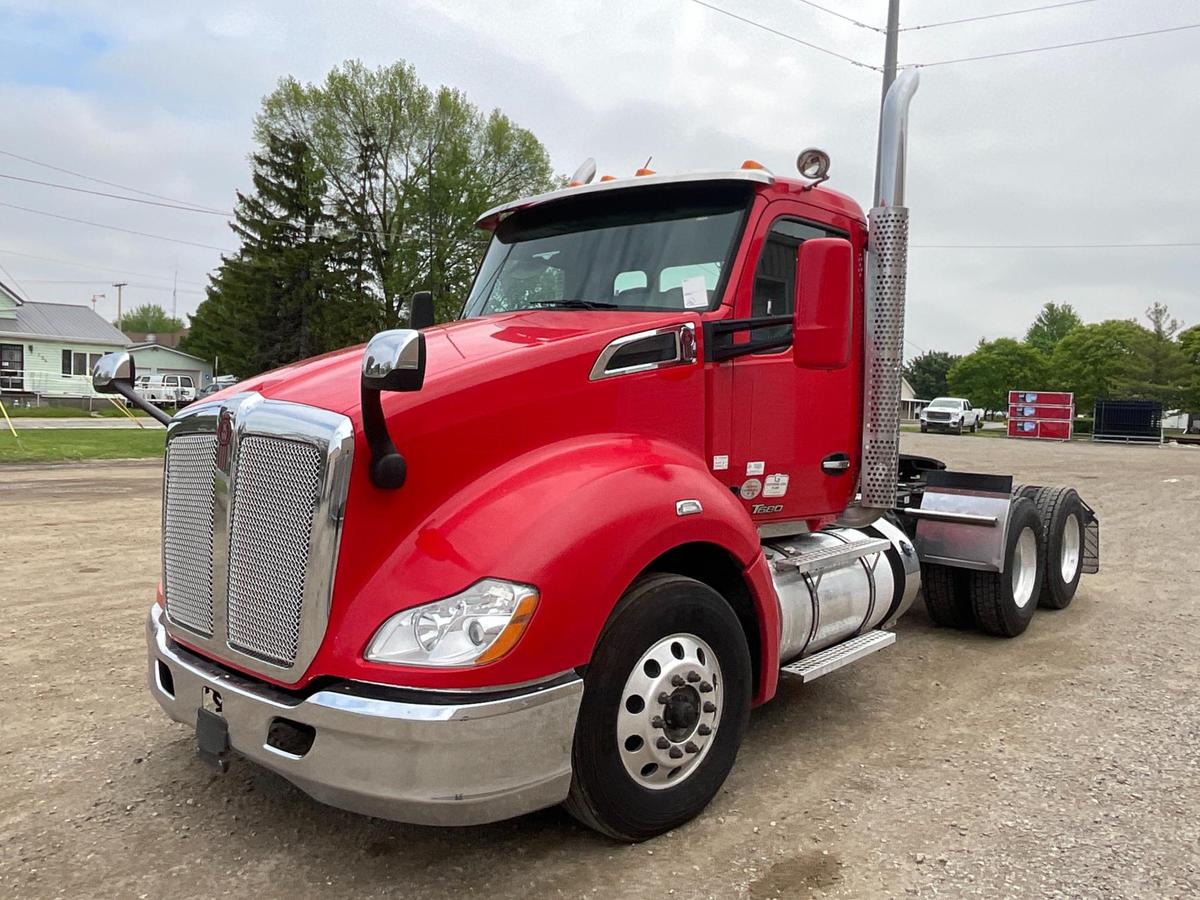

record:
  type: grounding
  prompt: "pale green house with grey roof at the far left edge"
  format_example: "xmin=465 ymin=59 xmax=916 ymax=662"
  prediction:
xmin=0 ymin=282 xmax=128 ymax=403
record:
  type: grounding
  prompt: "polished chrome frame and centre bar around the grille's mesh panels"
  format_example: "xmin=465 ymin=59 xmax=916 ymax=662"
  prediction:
xmin=162 ymin=391 xmax=354 ymax=680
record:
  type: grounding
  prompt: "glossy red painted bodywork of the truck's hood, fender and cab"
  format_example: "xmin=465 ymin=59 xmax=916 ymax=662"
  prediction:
xmin=169 ymin=180 xmax=865 ymax=702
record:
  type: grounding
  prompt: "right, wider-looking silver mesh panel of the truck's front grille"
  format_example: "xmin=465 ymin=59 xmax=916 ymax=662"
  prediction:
xmin=228 ymin=434 xmax=322 ymax=666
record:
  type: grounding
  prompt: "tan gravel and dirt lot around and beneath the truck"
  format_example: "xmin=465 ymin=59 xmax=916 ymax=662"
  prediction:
xmin=0 ymin=434 xmax=1200 ymax=900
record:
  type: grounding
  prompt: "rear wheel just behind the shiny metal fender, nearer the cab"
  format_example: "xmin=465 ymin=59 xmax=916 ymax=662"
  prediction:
xmin=968 ymin=498 xmax=1042 ymax=637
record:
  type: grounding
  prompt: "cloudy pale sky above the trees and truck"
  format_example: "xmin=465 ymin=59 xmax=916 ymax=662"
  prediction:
xmin=0 ymin=0 xmax=1200 ymax=354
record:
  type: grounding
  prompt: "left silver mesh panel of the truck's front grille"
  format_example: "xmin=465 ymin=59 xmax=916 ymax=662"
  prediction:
xmin=162 ymin=433 xmax=217 ymax=636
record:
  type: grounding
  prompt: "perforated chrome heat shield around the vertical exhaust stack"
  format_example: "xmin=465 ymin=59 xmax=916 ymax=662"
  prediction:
xmin=860 ymin=206 xmax=908 ymax=509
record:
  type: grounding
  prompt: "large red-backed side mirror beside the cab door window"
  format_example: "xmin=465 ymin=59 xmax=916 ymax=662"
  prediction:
xmin=792 ymin=238 xmax=854 ymax=368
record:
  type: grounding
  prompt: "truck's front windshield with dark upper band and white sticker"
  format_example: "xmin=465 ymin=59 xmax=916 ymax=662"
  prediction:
xmin=463 ymin=185 xmax=750 ymax=317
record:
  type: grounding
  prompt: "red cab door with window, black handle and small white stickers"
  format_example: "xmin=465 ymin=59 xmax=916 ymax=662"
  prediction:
xmin=730 ymin=202 xmax=862 ymax=527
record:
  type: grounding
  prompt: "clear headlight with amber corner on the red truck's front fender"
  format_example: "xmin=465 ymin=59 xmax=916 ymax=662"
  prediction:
xmin=366 ymin=578 xmax=538 ymax=666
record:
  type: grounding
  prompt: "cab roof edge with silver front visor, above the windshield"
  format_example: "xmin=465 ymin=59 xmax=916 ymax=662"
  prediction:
xmin=475 ymin=169 xmax=865 ymax=230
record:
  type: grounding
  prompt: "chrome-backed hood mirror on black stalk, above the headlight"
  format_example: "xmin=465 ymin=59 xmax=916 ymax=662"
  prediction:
xmin=361 ymin=329 xmax=425 ymax=490
